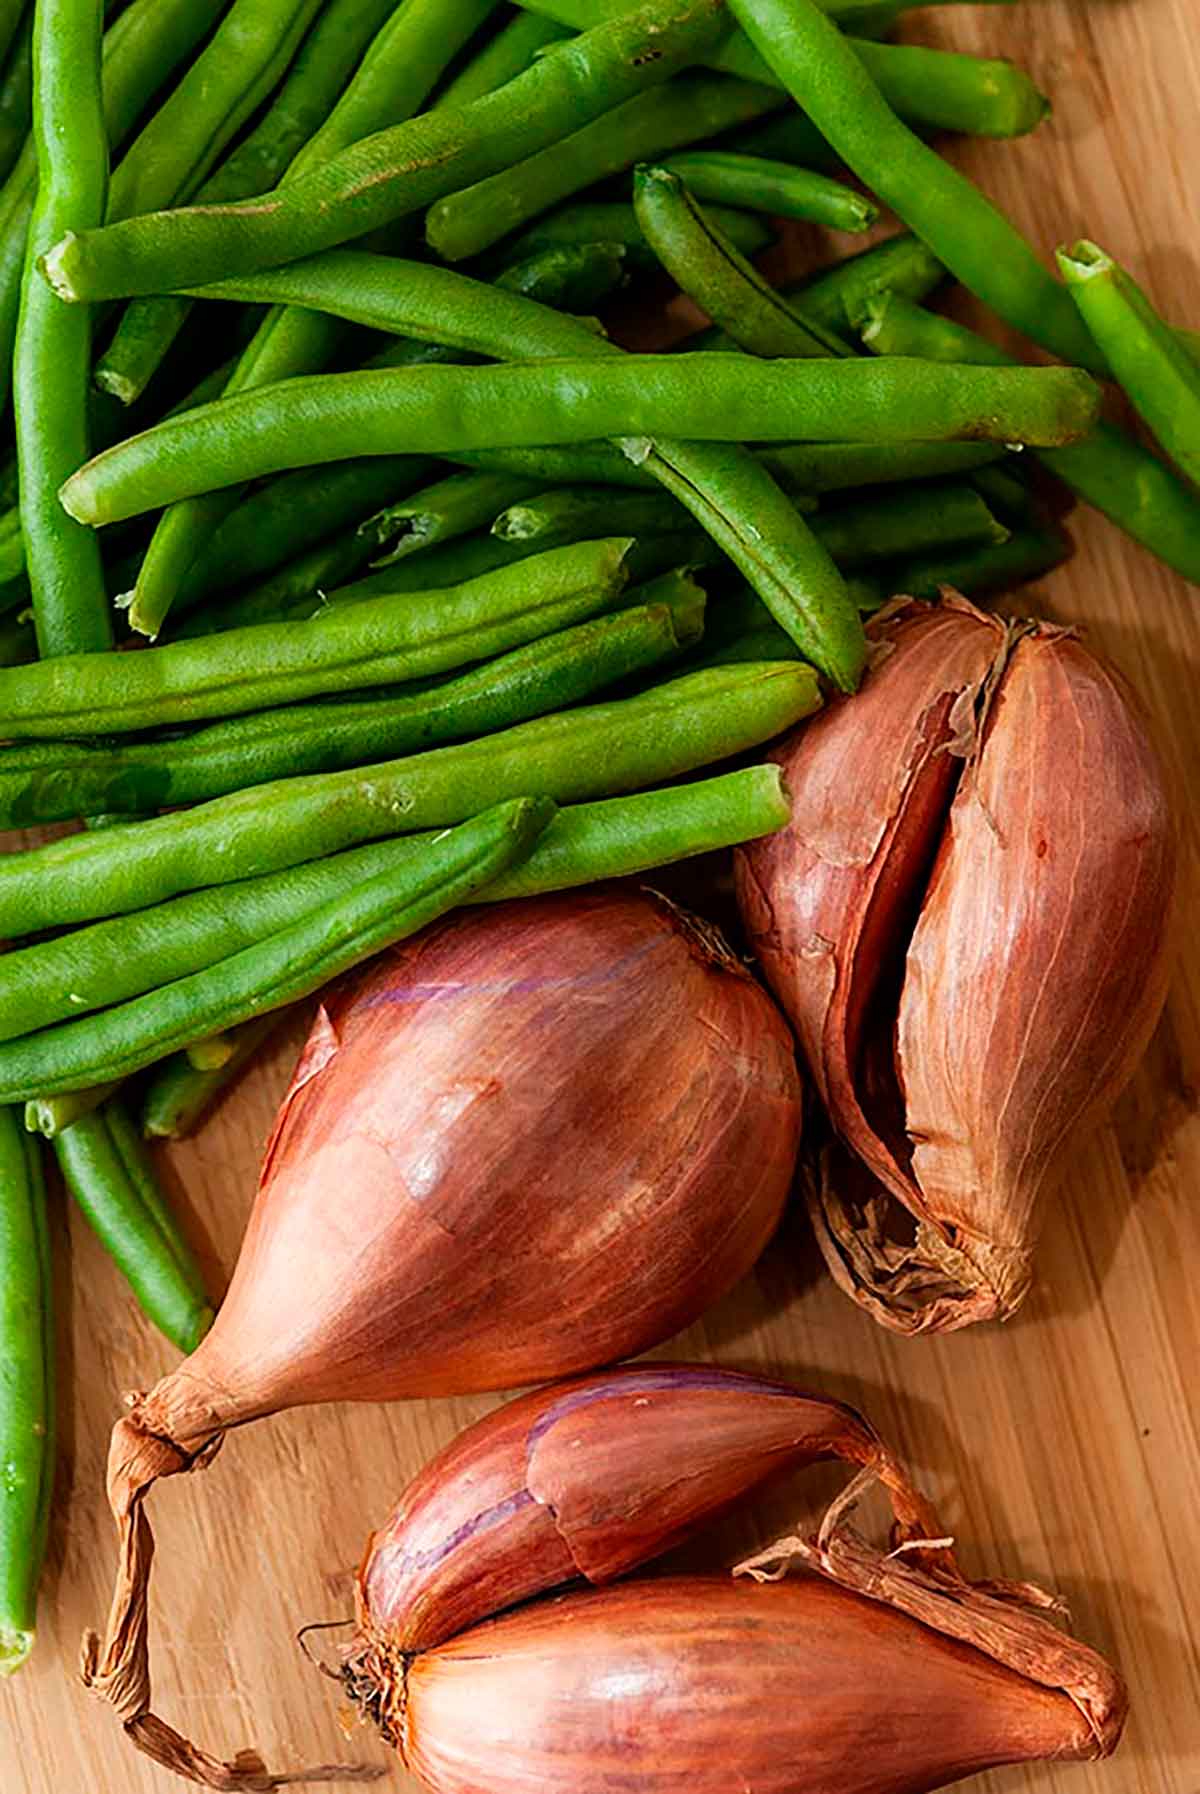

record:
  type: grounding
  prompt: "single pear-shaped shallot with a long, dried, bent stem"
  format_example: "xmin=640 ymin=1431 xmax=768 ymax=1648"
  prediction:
xmin=84 ymin=888 xmax=800 ymax=1787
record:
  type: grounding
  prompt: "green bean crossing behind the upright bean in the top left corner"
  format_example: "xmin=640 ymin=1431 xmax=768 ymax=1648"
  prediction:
xmin=0 ymin=0 xmax=234 ymax=410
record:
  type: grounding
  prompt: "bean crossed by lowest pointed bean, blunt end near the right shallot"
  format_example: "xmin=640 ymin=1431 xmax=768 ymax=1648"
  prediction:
xmin=7 ymin=766 xmax=787 ymax=1039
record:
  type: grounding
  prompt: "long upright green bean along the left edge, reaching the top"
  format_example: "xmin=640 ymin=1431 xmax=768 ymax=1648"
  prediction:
xmin=13 ymin=0 xmax=113 ymax=655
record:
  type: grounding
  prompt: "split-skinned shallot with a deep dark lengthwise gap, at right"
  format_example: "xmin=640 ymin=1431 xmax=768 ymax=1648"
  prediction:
xmin=737 ymin=599 xmax=1178 ymax=1333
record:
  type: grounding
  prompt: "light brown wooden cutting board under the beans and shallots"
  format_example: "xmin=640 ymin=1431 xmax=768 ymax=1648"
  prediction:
xmin=0 ymin=0 xmax=1200 ymax=1794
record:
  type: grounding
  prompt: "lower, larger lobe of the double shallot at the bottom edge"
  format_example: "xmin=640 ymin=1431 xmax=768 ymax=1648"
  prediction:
xmin=396 ymin=1577 xmax=1121 ymax=1794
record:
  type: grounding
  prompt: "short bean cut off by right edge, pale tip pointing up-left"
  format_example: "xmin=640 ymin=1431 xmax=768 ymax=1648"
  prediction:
xmin=1058 ymin=240 xmax=1200 ymax=483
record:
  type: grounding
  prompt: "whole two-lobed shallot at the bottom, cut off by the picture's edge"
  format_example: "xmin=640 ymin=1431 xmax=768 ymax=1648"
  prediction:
xmin=344 ymin=1365 xmax=1126 ymax=1794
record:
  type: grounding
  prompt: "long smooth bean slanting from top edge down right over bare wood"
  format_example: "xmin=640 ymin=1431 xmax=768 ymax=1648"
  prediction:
xmin=730 ymin=0 xmax=1103 ymax=371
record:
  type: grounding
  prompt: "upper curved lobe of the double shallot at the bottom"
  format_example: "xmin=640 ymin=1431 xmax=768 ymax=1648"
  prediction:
xmin=348 ymin=1363 xmax=931 ymax=1650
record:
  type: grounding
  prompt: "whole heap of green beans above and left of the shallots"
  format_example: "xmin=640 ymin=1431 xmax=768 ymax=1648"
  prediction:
xmin=0 ymin=0 xmax=1200 ymax=1672
